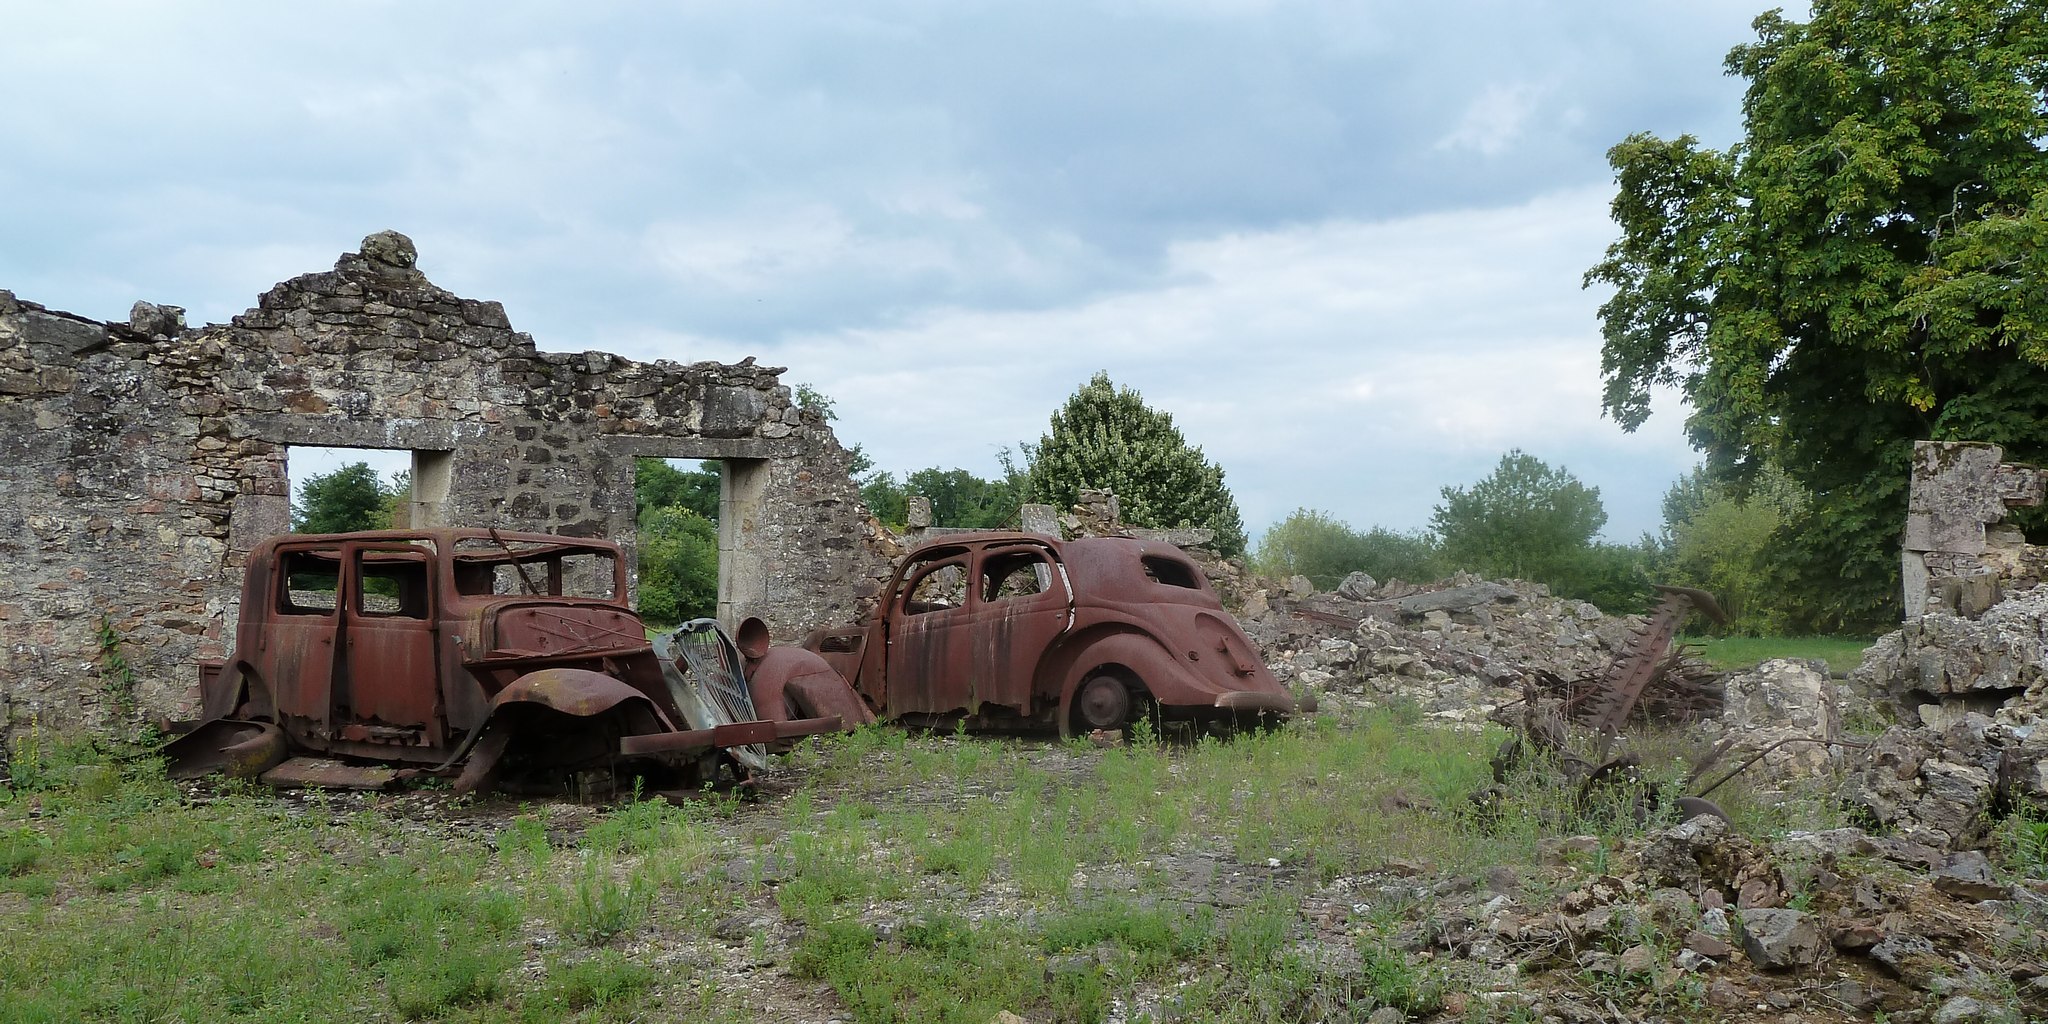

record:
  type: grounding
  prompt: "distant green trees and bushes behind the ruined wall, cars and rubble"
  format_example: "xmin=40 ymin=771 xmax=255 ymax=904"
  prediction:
xmin=293 ymin=373 xmax=1843 ymax=633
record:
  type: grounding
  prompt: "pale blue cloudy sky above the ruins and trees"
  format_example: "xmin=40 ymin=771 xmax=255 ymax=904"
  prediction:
xmin=0 ymin=0 xmax=1794 ymax=541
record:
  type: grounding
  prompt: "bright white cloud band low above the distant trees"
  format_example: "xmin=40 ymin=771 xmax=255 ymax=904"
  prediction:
xmin=621 ymin=188 xmax=1692 ymax=537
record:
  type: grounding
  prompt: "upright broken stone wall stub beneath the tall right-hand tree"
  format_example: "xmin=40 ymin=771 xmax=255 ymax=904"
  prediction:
xmin=1903 ymin=440 xmax=2048 ymax=621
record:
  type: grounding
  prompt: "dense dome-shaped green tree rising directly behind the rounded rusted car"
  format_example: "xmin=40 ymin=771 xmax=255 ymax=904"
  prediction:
xmin=1024 ymin=373 xmax=1245 ymax=555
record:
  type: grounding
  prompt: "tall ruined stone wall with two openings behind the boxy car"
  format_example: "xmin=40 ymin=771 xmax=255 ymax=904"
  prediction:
xmin=0 ymin=231 xmax=879 ymax=735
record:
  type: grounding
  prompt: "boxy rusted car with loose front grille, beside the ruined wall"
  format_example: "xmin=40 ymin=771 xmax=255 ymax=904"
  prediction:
xmin=170 ymin=528 xmax=842 ymax=793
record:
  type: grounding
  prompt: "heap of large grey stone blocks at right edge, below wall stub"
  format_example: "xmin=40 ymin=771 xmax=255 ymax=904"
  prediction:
xmin=1847 ymin=586 xmax=2048 ymax=850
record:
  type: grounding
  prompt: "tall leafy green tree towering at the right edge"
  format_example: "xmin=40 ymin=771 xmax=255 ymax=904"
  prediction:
xmin=1587 ymin=0 xmax=2048 ymax=629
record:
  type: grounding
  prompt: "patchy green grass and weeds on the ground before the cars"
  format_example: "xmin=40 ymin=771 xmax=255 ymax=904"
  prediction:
xmin=0 ymin=711 xmax=1875 ymax=1024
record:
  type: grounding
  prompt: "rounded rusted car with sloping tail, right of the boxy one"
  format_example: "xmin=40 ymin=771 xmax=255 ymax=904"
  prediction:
xmin=803 ymin=532 xmax=1294 ymax=735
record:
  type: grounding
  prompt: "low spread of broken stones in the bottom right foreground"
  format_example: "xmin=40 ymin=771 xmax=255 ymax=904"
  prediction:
xmin=1311 ymin=817 xmax=2048 ymax=1024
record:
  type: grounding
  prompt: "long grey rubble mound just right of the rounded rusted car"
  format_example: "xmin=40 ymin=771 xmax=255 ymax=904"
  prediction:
xmin=1239 ymin=573 xmax=1645 ymax=725
